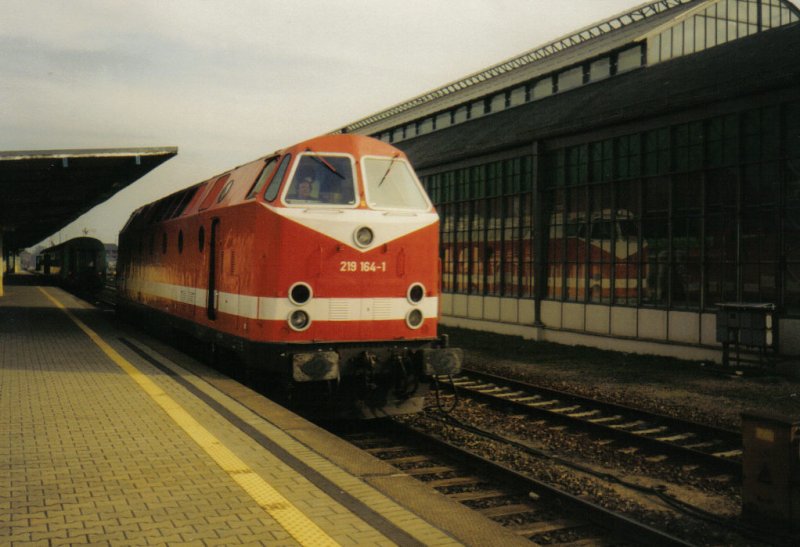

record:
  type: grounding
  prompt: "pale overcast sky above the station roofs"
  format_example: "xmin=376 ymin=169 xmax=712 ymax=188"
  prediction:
xmin=0 ymin=0 xmax=792 ymax=248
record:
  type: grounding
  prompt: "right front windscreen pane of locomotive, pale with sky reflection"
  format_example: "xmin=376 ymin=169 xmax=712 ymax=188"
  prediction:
xmin=363 ymin=157 xmax=430 ymax=211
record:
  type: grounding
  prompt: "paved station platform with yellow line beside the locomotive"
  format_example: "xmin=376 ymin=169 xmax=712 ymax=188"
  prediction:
xmin=0 ymin=278 xmax=530 ymax=546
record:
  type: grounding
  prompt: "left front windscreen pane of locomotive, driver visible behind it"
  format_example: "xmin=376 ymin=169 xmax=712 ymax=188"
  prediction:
xmin=283 ymin=154 xmax=356 ymax=207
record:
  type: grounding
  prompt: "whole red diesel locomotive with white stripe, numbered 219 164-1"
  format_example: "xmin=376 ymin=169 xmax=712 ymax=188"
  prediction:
xmin=117 ymin=135 xmax=462 ymax=417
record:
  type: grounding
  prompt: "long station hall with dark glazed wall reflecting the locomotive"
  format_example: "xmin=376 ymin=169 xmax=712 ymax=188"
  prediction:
xmin=340 ymin=0 xmax=800 ymax=361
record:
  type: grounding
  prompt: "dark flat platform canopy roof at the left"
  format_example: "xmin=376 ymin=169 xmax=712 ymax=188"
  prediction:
xmin=0 ymin=147 xmax=178 ymax=250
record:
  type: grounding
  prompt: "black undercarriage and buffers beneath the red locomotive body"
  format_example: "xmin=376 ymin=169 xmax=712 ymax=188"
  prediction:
xmin=118 ymin=303 xmax=463 ymax=419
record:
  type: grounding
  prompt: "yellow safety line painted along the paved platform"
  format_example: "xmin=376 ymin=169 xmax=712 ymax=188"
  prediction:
xmin=39 ymin=287 xmax=338 ymax=546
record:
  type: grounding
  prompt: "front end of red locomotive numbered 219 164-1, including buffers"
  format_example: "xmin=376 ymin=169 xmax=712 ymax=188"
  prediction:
xmin=266 ymin=139 xmax=462 ymax=418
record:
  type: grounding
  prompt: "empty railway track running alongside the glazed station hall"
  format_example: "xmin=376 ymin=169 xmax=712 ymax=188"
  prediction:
xmin=453 ymin=369 xmax=742 ymax=477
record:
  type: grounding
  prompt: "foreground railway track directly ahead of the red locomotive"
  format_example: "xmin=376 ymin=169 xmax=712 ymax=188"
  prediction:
xmin=335 ymin=420 xmax=688 ymax=545
